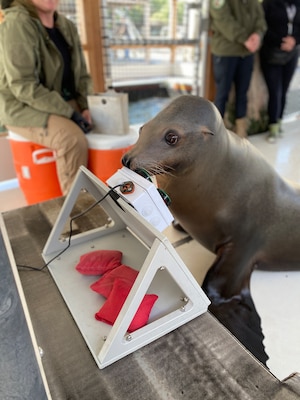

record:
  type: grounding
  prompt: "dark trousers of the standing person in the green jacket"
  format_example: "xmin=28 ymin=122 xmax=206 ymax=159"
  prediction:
xmin=213 ymin=55 xmax=254 ymax=118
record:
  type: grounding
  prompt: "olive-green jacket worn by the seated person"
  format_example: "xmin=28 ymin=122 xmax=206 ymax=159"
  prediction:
xmin=0 ymin=1 xmax=92 ymax=127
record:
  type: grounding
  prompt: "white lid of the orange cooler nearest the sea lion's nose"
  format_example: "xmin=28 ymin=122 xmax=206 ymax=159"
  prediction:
xmin=86 ymin=127 xmax=138 ymax=150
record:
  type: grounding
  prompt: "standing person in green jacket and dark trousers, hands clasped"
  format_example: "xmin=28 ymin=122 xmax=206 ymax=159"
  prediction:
xmin=210 ymin=0 xmax=266 ymax=137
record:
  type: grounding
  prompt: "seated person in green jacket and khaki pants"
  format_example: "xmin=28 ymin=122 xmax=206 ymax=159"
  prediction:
xmin=0 ymin=0 xmax=92 ymax=194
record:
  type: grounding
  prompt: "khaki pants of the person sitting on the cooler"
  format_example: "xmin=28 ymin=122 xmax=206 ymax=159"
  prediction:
xmin=7 ymin=115 xmax=88 ymax=195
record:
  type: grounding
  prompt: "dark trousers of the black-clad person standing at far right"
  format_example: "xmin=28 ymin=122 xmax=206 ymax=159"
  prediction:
xmin=260 ymin=54 xmax=299 ymax=124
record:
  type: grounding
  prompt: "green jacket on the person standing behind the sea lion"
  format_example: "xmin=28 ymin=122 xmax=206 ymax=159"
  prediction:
xmin=210 ymin=0 xmax=266 ymax=57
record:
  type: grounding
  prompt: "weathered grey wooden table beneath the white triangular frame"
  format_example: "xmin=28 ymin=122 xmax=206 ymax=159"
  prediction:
xmin=0 ymin=198 xmax=300 ymax=400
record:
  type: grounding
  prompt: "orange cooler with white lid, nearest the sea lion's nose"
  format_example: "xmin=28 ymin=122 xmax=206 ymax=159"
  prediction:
xmin=86 ymin=128 xmax=138 ymax=182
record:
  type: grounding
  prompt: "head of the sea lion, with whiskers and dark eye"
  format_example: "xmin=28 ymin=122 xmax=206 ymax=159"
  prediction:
xmin=122 ymin=95 xmax=226 ymax=176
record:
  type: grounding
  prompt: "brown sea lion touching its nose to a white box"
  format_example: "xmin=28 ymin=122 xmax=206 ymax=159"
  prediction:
xmin=122 ymin=95 xmax=300 ymax=363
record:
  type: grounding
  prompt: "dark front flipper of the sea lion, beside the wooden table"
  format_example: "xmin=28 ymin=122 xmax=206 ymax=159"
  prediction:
xmin=202 ymin=243 xmax=269 ymax=365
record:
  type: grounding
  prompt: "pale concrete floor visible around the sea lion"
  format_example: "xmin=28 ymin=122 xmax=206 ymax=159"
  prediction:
xmin=0 ymin=113 xmax=300 ymax=379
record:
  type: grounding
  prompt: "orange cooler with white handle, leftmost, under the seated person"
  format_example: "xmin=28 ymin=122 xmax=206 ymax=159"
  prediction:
xmin=9 ymin=132 xmax=62 ymax=204
